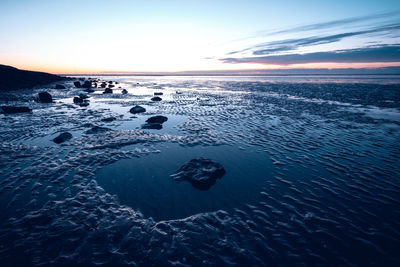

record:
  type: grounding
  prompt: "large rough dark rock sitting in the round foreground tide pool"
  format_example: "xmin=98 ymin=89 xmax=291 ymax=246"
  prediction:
xmin=171 ymin=158 xmax=225 ymax=190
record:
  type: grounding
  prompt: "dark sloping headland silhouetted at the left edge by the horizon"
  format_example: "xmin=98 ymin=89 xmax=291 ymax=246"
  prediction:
xmin=0 ymin=64 xmax=67 ymax=91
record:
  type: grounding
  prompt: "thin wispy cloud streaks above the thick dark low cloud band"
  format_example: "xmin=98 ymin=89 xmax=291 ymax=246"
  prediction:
xmin=226 ymin=11 xmax=400 ymax=57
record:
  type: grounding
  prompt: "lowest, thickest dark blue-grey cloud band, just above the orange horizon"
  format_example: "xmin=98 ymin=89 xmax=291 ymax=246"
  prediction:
xmin=220 ymin=45 xmax=400 ymax=65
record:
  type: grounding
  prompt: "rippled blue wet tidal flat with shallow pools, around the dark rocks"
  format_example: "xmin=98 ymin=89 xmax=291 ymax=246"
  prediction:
xmin=0 ymin=75 xmax=400 ymax=266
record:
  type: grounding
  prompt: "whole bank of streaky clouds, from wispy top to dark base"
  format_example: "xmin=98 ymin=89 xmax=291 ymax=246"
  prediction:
xmin=220 ymin=11 xmax=400 ymax=65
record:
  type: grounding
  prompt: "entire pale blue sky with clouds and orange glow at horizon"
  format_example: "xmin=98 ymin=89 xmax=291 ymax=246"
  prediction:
xmin=0 ymin=0 xmax=400 ymax=74
